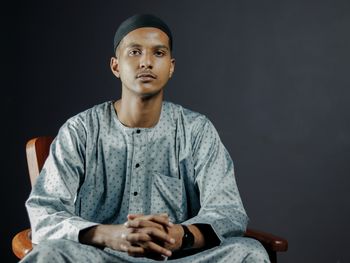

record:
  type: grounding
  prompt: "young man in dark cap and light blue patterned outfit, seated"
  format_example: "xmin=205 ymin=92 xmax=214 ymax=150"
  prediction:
xmin=23 ymin=15 xmax=268 ymax=262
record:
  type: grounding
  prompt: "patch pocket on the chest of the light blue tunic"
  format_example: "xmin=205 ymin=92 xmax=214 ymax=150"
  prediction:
xmin=151 ymin=173 xmax=187 ymax=223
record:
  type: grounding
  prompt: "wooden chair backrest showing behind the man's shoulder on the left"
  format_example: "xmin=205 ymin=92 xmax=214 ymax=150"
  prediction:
xmin=26 ymin=136 xmax=54 ymax=186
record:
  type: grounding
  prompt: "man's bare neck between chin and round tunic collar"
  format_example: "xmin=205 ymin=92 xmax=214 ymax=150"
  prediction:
xmin=114 ymin=93 xmax=163 ymax=128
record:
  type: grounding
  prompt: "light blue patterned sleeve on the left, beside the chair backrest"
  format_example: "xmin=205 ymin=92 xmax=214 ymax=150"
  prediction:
xmin=26 ymin=117 xmax=97 ymax=243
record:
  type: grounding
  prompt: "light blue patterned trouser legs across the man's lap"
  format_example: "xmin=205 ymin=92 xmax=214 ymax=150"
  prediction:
xmin=22 ymin=237 xmax=269 ymax=263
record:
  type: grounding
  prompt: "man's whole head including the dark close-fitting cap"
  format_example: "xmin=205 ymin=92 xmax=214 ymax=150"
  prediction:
xmin=111 ymin=15 xmax=175 ymax=99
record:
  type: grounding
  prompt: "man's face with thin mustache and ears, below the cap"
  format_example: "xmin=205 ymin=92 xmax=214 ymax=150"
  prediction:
xmin=111 ymin=27 xmax=175 ymax=97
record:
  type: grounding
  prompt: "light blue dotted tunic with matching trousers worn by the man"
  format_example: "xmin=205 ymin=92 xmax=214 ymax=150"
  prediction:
xmin=21 ymin=101 xmax=268 ymax=262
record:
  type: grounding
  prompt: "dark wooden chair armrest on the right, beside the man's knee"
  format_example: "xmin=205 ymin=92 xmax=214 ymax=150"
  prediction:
xmin=245 ymin=228 xmax=288 ymax=252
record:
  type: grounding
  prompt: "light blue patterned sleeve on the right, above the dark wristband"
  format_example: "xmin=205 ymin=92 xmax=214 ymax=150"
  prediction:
xmin=184 ymin=119 xmax=248 ymax=242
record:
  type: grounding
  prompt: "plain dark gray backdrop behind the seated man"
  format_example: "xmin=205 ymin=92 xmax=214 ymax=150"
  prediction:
xmin=1 ymin=0 xmax=350 ymax=262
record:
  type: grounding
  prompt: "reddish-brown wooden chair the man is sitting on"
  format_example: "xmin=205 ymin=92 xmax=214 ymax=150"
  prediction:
xmin=12 ymin=136 xmax=288 ymax=263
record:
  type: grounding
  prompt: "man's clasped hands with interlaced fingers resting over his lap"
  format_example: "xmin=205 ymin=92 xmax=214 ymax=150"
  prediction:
xmin=109 ymin=214 xmax=184 ymax=259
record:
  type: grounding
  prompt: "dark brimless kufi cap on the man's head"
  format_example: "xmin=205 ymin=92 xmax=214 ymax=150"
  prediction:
xmin=114 ymin=14 xmax=173 ymax=51
